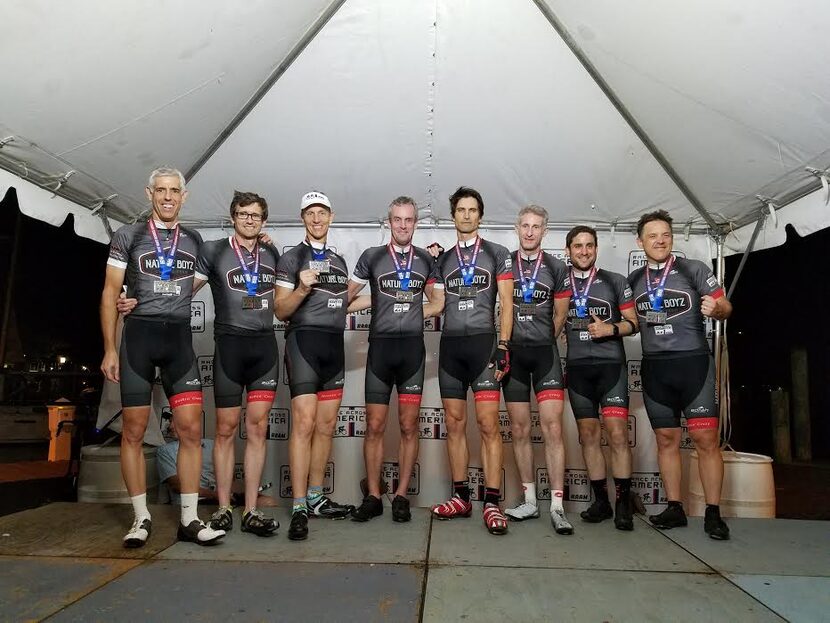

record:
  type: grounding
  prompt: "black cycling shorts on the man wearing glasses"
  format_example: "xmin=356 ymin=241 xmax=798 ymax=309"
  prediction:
xmin=213 ymin=333 xmax=280 ymax=409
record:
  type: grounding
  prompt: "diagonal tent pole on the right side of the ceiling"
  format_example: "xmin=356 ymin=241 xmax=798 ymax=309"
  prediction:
xmin=533 ymin=0 xmax=721 ymax=232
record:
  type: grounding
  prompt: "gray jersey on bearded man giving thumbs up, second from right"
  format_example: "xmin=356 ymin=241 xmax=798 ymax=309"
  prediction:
xmin=565 ymin=268 xmax=634 ymax=365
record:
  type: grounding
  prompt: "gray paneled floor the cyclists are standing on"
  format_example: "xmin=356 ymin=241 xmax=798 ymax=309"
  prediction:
xmin=0 ymin=503 xmax=830 ymax=623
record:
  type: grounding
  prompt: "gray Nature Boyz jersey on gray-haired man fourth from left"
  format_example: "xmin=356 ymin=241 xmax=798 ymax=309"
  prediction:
xmin=351 ymin=244 xmax=435 ymax=337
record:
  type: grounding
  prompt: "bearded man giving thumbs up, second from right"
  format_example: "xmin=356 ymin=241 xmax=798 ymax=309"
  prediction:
xmin=565 ymin=225 xmax=637 ymax=530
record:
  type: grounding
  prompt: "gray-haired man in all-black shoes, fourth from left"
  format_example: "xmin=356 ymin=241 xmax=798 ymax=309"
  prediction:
xmin=349 ymin=197 xmax=443 ymax=522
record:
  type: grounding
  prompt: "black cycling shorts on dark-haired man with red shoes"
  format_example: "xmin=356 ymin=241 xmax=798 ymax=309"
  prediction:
xmin=438 ymin=333 xmax=499 ymax=402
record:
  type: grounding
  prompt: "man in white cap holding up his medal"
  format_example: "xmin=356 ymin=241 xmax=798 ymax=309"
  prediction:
xmin=275 ymin=191 xmax=354 ymax=541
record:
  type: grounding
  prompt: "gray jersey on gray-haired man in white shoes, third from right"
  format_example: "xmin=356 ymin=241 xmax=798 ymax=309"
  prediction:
xmin=510 ymin=251 xmax=571 ymax=346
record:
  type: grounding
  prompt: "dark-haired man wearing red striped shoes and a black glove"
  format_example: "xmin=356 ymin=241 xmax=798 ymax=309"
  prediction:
xmin=432 ymin=186 xmax=513 ymax=534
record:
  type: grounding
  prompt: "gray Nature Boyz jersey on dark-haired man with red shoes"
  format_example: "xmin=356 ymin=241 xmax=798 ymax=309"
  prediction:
xmin=435 ymin=239 xmax=513 ymax=336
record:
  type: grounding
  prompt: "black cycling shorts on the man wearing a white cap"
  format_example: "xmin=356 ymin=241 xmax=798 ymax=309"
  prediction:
xmin=285 ymin=329 xmax=346 ymax=400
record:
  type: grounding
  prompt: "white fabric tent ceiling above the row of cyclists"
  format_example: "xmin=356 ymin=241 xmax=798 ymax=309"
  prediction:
xmin=0 ymin=0 xmax=830 ymax=249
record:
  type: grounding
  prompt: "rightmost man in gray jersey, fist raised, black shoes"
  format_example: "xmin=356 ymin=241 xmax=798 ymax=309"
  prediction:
xmin=628 ymin=210 xmax=732 ymax=540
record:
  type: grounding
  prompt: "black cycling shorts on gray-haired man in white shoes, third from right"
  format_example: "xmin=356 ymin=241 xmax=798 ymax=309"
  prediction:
xmin=502 ymin=344 xmax=565 ymax=402
